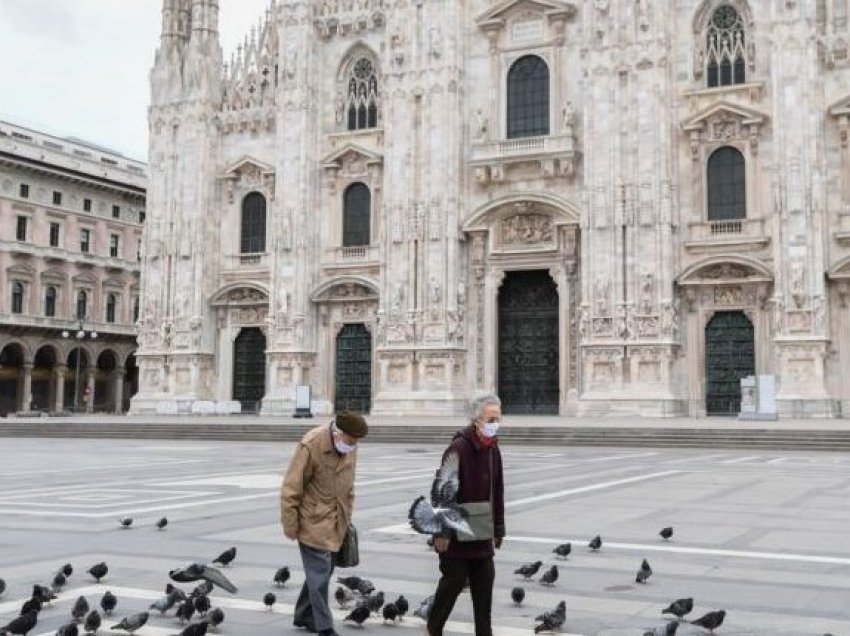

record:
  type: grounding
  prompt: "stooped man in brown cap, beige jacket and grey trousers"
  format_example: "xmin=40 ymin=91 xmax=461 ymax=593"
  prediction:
xmin=280 ymin=412 xmax=369 ymax=636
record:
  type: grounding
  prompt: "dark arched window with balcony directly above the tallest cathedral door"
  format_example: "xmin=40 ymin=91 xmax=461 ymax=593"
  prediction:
xmin=508 ymin=55 xmax=549 ymax=139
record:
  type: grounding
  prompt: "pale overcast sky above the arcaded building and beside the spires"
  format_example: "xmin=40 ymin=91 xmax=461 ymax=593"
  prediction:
xmin=0 ymin=0 xmax=269 ymax=161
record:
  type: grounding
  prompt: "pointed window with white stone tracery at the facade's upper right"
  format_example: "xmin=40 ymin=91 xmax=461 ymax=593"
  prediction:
xmin=705 ymin=4 xmax=747 ymax=87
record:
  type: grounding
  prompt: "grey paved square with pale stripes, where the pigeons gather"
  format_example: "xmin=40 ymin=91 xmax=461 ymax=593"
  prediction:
xmin=0 ymin=439 xmax=850 ymax=636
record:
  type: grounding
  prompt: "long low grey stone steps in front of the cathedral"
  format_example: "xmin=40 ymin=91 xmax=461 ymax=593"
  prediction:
xmin=0 ymin=418 xmax=850 ymax=452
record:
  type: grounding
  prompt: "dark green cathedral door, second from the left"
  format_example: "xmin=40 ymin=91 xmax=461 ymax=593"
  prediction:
xmin=334 ymin=323 xmax=372 ymax=413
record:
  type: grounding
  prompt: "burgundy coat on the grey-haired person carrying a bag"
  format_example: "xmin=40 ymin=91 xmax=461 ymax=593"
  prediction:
xmin=443 ymin=426 xmax=505 ymax=559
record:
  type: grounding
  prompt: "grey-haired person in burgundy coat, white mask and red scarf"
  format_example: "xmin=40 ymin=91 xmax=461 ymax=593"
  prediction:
xmin=427 ymin=394 xmax=505 ymax=636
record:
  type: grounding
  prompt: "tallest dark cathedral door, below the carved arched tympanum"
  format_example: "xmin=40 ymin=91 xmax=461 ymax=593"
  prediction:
xmin=499 ymin=270 xmax=559 ymax=415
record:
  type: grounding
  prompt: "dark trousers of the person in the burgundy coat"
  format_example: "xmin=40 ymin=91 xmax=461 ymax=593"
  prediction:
xmin=428 ymin=555 xmax=496 ymax=636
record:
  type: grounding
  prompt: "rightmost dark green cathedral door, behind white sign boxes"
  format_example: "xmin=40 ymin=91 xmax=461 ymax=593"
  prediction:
xmin=705 ymin=311 xmax=756 ymax=415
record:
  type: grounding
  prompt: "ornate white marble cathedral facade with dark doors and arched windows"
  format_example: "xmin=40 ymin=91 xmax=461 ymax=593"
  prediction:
xmin=132 ymin=0 xmax=850 ymax=417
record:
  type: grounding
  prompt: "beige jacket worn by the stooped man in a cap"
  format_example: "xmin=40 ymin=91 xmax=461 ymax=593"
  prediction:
xmin=280 ymin=424 xmax=357 ymax=552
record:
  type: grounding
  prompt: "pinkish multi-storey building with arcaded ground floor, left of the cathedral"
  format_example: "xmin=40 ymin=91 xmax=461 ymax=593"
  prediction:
xmin=0 ymin=121 xmax=147 ymax=414
